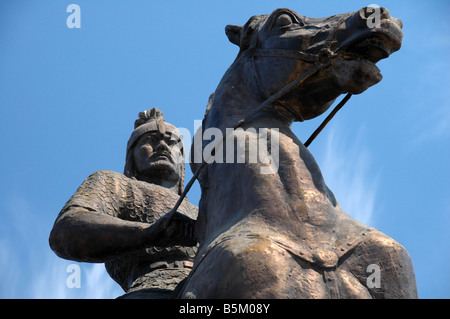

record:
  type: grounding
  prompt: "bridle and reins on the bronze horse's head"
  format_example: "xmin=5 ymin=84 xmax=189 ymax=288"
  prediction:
xmin=165 ymin=16 xmax=352 ymax=226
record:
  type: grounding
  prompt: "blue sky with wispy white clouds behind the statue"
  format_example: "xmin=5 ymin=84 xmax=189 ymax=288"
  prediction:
xmin=0 ymin=0 xmax=450 ymax=298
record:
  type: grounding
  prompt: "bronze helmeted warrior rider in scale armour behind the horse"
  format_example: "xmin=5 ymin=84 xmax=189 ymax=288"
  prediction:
xmin=50 ymin=108 xmax=198 ymax=298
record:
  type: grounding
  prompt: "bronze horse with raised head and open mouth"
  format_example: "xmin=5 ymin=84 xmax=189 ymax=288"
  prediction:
xmin=178 ymin=7 xmax=417 ymax=299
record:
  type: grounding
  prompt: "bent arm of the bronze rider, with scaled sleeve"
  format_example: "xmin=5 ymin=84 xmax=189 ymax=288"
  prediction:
xmin=49 ymin=174 xmax=193 ymax=262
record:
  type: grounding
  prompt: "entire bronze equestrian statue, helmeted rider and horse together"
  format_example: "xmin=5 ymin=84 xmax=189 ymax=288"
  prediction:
xmin=50 ymin=8 xmax=417 ymax=299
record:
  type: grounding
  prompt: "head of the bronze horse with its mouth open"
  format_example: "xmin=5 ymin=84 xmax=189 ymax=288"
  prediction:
xmin=226 ymin=7 xmax=403 ymax=121
